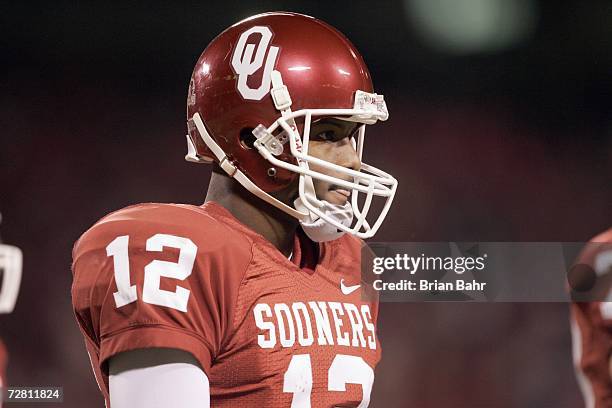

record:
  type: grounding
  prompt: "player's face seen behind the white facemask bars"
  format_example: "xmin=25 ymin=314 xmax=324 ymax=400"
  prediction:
xmin=308 ymin=118 xmax=361 ymax=205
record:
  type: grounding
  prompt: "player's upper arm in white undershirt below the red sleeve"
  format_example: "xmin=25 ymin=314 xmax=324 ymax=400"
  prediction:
xmin=109 ymin=348 xmax=210 ymax=408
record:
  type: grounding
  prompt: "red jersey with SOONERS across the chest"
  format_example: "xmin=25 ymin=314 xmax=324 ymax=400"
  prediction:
xmin=72 ymin=202 xmax=381 ymax=408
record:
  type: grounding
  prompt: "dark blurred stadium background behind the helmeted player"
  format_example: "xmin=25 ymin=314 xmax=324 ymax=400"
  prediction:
xmin=0 ymin=0 xmax=612 ymax=408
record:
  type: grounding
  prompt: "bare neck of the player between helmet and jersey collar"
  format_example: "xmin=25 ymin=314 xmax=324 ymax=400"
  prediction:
xmin=205 ymin=172 xmax=298 ymax=256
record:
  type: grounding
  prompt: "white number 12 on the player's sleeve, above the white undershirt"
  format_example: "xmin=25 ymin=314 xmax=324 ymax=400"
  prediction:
xmin=106 ymin=234 xmax=198 ymax=312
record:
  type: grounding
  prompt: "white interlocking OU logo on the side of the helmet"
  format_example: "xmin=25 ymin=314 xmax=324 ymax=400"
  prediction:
xmin=232 ymin=26 xmax=279 ymax=101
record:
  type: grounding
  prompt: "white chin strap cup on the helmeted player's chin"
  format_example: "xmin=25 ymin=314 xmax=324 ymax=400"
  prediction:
xmin=295 ymin=198 xmax=353 ymax=242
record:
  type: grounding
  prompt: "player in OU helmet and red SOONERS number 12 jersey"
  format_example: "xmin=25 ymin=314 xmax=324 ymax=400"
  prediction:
xmin=72 ymin=12 xmax=397 ymax=408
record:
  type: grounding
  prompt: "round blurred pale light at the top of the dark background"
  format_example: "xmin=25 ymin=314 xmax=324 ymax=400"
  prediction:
xmin=404 ymin=0 xmax=538 ymax=55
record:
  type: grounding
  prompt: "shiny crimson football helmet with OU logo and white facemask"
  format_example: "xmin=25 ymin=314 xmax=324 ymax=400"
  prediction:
xmin=186 ymin=12 xmax=397 ymax=238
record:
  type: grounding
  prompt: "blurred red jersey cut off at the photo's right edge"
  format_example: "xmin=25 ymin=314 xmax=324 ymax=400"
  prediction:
xmin=571 ymin=229 xmax=612 ymax=408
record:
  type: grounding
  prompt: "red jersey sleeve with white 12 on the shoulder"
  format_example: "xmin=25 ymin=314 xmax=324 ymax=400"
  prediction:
xmin=72 ymin=206 xmax=250 ymax=373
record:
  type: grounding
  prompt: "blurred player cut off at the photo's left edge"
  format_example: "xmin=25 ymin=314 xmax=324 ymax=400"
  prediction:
xmin=0 ymin=214 xmax=23 ymax=407
